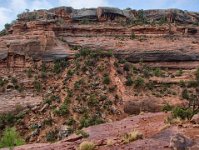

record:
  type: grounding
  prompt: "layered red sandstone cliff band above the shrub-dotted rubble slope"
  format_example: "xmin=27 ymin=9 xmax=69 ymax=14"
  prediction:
xmin=0 ymin=7 xmax=199 ymax=67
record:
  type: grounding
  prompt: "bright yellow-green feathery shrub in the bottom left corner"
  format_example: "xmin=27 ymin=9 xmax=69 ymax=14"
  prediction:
xmin=0 ymin=128 xmax=25 ymax=149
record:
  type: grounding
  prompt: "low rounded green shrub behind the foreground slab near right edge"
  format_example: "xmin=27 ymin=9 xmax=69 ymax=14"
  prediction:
xmin=172 ymin=107 xmax=193 ymax=119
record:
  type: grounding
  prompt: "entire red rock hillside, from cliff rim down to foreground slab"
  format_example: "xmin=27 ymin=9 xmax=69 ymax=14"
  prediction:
xmin=0 ymin=7 xmax=199 ymax=149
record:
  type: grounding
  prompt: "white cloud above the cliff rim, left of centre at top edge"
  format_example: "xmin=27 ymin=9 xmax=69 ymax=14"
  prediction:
xmin=59 ymin=0 xmax=109 ymax=8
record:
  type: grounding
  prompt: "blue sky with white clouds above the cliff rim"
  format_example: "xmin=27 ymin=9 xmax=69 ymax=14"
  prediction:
xmin=0 ymin=0 xmax=199 ymax=30
